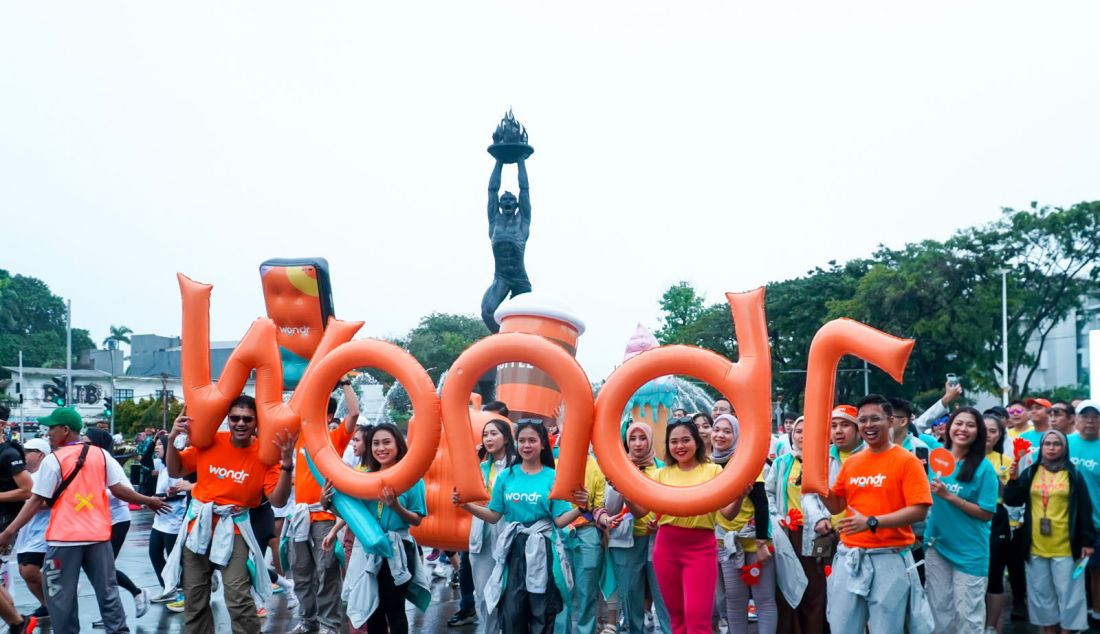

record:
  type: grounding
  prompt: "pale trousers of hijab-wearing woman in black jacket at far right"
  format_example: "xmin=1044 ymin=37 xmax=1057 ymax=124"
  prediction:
xmin=1026 ymin=555 xmax=1089 ymax=632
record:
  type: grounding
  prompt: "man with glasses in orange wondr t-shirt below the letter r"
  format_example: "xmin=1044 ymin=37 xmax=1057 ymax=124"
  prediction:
xmin=822 ymin=394 xmax=932 ymax=634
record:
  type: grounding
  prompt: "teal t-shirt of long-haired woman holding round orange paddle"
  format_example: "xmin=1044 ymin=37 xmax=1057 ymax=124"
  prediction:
xmin=924 ymin=460 xmax=998 ymax=577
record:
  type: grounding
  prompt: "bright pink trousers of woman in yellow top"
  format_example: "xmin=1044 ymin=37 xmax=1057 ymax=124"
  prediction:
xmin=653 ymin=525 xmax=718 ymax=634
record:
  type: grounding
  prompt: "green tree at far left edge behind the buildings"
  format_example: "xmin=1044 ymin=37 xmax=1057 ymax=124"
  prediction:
xmin=0 ymin=270 xmax=96 ymax=368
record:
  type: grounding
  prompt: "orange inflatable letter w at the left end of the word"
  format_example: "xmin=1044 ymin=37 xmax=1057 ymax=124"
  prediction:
xmin=176 ymin=273 xmax=363 ymax=464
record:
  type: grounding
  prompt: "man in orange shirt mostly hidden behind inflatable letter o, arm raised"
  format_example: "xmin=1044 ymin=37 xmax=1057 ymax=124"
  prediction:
xmin=279 ymin=378 xmax=359 ymax=634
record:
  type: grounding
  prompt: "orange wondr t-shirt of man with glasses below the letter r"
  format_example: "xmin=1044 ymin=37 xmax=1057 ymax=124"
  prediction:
xmin=833 ymin=445 xmax=932 ymax=548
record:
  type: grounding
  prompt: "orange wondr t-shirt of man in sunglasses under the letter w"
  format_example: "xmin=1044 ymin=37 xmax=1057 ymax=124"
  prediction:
xmin=179 ymin=431 xmax=279 ymax=509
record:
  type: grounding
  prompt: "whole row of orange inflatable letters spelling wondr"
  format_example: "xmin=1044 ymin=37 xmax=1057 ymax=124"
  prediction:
xmin=177 ymin=269 xmax=913 ymax=515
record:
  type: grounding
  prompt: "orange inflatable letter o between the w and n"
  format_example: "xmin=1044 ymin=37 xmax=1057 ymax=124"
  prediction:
xmin=295 ymin=339 xmax=444 ymax=500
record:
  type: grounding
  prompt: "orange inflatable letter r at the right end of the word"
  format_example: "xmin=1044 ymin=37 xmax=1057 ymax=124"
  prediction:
xmin=802 ymin=319 xmax=914 ymax=495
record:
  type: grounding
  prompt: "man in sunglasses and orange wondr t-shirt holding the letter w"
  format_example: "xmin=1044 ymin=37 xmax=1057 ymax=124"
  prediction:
xmin=162 ymin=394 xmax=296 ymax=634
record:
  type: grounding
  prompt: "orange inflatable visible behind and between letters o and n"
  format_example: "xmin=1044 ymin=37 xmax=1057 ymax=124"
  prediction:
xmin=410 ymin=409 xmax=503 ymax=550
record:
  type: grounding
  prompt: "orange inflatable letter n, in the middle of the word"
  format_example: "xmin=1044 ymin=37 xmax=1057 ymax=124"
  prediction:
xmin=442 ymin=332 xmax=593 ymax=502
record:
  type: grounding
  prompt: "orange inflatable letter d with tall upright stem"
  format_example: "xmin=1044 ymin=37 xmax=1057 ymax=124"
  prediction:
xmin=594 ymin=288 xmax=771 ymax=515
